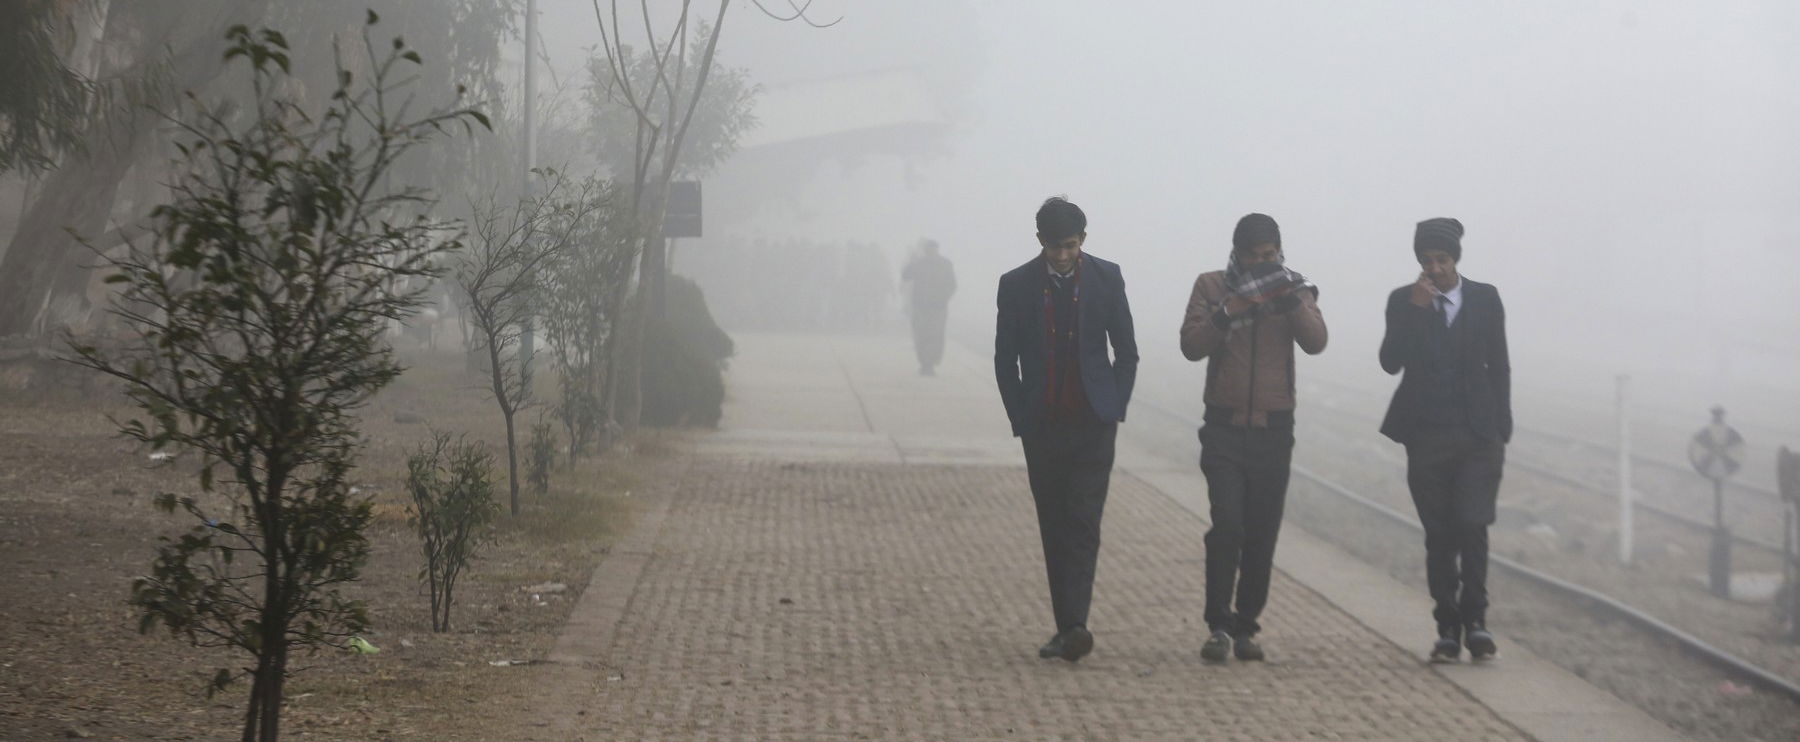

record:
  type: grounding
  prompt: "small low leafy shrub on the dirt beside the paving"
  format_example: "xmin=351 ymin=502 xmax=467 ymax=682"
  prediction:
xmin=407 ymin=432 xmax=500 ymax=632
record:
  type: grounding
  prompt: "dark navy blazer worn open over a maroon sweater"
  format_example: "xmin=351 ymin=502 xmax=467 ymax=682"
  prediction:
xmin=994 ymin=254 xmax=1138 ymax=436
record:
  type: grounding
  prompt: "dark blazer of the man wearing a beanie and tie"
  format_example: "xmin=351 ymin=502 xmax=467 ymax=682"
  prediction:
xmin=1381 ymin=277 xmax=1512 ymax=443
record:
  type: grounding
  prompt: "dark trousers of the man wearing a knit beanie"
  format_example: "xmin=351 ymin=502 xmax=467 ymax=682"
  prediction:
xmin=1406 ymin=425 xmax=1507 ymax=627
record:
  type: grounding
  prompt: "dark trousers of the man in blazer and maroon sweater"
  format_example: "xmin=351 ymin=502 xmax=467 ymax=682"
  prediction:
xmin=1024 ymin=421 xmax=1120 ymax=632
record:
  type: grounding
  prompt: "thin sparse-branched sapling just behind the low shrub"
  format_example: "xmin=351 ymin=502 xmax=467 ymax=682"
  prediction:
xmin=452 ymin=171 xmax=601 ymax=515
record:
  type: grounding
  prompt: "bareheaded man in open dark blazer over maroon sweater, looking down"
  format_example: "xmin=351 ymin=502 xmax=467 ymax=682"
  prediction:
xmin=994 ymin=196 xmax=1138 ymax=663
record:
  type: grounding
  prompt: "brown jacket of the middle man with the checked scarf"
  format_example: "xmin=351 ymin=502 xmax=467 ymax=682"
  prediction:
xmin=1181 ymin=270 xmax=1325 ymax=427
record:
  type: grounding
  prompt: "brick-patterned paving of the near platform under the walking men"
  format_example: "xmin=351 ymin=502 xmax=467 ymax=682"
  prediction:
xmin=576 ymin=457 xmax=1525 ymax=740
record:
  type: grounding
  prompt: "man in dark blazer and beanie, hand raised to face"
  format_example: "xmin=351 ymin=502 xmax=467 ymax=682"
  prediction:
xmin=1381 ymin=218 xmax=1512 ymax=661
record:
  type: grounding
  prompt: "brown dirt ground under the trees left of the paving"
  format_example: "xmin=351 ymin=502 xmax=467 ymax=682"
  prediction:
xmin=0 ymin=353 xmax=686 ymax=742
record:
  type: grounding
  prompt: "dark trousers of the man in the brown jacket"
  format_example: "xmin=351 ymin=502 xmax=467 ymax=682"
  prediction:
xmin=1201 ymin=418 xmax=1294 ymax=636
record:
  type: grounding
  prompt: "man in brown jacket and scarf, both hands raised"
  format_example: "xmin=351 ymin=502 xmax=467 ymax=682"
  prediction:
xmin=1181 ymin=214 xmax=1327 ymax=663
